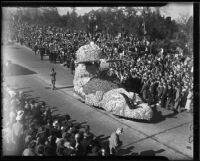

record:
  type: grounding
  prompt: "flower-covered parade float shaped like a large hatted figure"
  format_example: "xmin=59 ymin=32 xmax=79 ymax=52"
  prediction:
xmin=73 ymin=42 xmax=153 ymax=121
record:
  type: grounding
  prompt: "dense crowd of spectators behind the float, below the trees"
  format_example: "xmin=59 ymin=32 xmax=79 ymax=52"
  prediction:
xmin=8 ymin=20 xmax=193 ymax=112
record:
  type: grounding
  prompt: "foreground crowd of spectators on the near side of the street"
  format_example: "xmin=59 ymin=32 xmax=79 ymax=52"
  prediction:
xmin=3 ymin=86 xmax=109 ymax=156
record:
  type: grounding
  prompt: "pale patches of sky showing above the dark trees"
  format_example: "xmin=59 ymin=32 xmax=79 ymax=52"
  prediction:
xmin=57 ymin=2 xmax=193 ymax=20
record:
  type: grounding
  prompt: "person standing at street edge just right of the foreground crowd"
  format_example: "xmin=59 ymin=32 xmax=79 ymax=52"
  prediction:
xmin=109 ymin=128 xmax=123 ymax=155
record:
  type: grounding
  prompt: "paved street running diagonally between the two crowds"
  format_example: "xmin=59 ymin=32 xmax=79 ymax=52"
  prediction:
xmin=2 ymin=44 xmax=193 ymax=160
